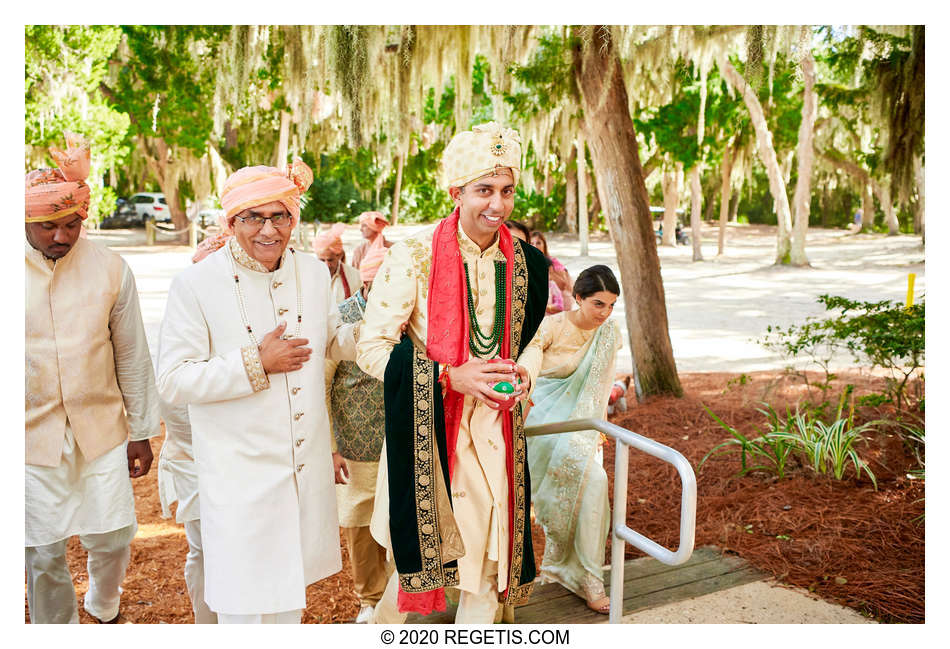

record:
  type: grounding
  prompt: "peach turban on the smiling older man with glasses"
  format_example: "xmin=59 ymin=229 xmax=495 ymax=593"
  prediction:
xmin=221 ymin=158 xmax=313 ymax=225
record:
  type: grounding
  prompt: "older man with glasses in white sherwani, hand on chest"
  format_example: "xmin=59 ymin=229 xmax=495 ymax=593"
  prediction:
xmin=158 ymin=160 xmax=355 ymax=623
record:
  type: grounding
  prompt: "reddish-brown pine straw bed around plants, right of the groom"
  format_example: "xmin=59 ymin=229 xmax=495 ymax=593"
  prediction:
xmin=604 ymin=371 xmax=924 ymax=623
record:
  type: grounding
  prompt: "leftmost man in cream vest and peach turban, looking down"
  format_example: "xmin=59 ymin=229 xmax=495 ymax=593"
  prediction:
xmin=25 ymin=135 xmax=160 ymax=623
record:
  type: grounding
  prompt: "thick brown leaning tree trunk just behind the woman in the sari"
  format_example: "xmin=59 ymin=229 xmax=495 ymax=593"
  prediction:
xmin=574 ymin=26 xmax=683 ymax=398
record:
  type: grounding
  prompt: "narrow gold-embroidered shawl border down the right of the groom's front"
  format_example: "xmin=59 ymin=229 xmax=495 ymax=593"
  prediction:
xmin=505 ymin=244 xmax=534 ymax=606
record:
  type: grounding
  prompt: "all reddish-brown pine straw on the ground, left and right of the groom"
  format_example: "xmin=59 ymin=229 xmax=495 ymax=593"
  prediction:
xmin=24 ymin=372 xmax=924 ymax=624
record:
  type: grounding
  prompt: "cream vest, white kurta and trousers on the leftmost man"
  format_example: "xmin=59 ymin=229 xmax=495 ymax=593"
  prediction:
xmin=24 ymin=239 xmax=160 ymax=623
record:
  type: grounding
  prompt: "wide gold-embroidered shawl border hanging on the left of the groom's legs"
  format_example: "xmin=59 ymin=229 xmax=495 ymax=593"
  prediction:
xmin=399 ymin=346 xmax=459 ymax=593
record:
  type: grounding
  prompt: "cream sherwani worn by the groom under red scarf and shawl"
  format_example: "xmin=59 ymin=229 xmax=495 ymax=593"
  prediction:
xmin=357 ymin=226 xmax=541 ymax=593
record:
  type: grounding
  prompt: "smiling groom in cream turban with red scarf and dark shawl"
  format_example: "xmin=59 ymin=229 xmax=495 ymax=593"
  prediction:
xmin=357 ymin=123 xmax=548 ymax=623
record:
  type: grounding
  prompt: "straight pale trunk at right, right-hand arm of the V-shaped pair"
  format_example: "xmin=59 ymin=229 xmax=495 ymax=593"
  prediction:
xmin=790 ymin=50 xmax=818 ymax=266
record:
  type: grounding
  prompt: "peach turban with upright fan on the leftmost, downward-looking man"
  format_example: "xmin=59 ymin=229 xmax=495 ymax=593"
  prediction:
xmin=26 ymin=133 xmax=90 ymax=223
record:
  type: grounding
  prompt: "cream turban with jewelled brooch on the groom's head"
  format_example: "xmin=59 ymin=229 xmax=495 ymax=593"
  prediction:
xmin=442 ymin=122 xmax=521 ymax=189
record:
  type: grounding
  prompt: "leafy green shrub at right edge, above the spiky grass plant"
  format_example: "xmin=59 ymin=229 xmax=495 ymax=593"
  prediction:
xmin=759 ymin=295 xmax=925 ymax=410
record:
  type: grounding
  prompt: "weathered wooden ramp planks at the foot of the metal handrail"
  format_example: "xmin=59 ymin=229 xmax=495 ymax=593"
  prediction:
xmin=406 ymin=546 xmax=766 ymax=624
